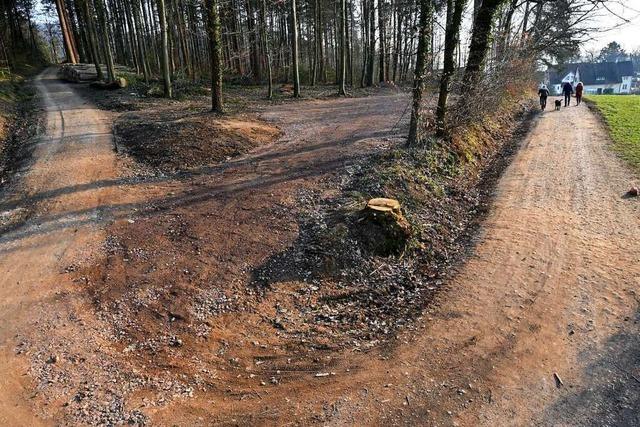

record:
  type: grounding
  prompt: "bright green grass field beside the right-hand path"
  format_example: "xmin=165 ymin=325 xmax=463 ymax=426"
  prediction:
xmin=588 ymin=95 xmax=640 ymax=170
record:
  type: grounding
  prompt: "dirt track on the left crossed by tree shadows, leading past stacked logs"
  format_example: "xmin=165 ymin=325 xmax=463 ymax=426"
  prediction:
xmin=0 ymin=68 xmax=144 ymax=426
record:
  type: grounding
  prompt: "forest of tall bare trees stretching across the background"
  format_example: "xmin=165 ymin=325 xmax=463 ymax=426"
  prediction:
xmin=0 ymin=0 xmax=607 ymax=137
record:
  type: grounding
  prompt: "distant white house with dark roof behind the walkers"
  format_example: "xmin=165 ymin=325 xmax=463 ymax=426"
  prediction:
xmin=547 ymin=61 xmax=635 ymax=94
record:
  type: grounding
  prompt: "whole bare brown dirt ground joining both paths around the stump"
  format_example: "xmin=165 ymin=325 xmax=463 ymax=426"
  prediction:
xmin=0 ymin=70 xmax=640 ymax=425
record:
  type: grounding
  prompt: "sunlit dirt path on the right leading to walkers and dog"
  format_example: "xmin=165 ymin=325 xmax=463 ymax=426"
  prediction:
xmin=282 ymin=102 xmax=640 ymax=426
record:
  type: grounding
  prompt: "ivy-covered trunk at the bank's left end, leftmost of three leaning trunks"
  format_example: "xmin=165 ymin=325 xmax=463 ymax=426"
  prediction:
xmin=407 ymin=0 xmax=433 ymax=145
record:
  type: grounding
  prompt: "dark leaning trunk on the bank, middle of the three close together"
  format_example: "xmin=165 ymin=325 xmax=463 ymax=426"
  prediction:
xmin=436 ymin=0 xmax=467 ymax=136
